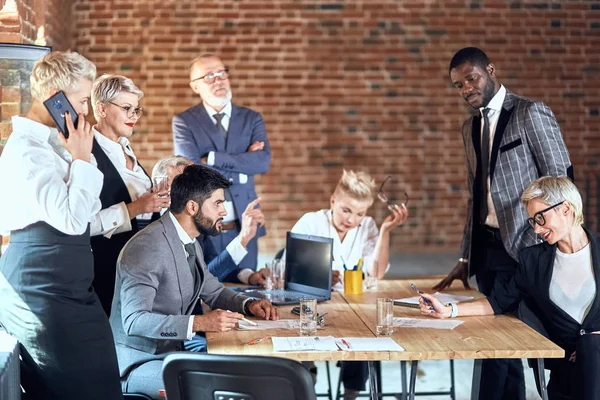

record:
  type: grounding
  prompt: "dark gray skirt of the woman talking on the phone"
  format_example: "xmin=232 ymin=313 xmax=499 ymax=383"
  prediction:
xmin=0 ymin=222 xmax=123 ymax=400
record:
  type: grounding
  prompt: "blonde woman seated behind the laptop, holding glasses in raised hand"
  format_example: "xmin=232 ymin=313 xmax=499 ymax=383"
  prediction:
xmin=292 ymin=170 xmax=408 ymax=399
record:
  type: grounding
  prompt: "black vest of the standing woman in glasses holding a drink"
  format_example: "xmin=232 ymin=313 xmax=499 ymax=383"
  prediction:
xmin=91 ymin=139 xmax=160 ymax=316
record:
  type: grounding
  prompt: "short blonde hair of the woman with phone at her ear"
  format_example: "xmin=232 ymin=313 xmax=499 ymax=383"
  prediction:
xmin=29 ymin=51 xmax=96 ymax=101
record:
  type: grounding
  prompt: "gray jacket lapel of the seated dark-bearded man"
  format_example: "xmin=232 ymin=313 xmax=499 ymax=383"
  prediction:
xmin=160 ymin=212 xmax=198 ymax=314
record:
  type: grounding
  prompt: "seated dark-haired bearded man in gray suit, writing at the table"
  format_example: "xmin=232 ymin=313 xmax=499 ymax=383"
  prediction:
xmin=110 ymin=165 xmax=279 ymax=399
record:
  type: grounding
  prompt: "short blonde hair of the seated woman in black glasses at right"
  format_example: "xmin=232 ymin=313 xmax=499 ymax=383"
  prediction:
xmin=521 ymin=176 xmax=583 ymax=225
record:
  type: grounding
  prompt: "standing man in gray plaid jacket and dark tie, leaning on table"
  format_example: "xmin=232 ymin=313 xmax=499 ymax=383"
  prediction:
xmin=434 ymin=47 xmax=573 ymax=400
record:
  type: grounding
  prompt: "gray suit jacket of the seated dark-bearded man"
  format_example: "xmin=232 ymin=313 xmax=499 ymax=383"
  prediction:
xmin=110 ymin=213 xmax=247 ymax=377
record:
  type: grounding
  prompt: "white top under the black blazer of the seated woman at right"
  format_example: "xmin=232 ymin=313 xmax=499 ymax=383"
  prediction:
xmin=550 ymin=243 xmax=596 ymax=324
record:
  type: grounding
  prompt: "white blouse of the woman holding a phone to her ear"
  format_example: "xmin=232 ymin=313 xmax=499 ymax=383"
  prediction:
xmin=0 ymin=117 xmax=104 ymax=235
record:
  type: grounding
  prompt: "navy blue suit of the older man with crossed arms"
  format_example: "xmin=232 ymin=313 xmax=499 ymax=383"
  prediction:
xmin=173 ymin=104 xmax=271 ymax=270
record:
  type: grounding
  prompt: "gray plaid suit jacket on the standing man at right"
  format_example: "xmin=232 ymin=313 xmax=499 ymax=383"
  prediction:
xmin=461 ymin=90 xmax=573 ymax=271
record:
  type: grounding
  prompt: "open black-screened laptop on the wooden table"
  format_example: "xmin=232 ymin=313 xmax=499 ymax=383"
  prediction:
xmin=244 ymin=232 xmax=333 ymax=306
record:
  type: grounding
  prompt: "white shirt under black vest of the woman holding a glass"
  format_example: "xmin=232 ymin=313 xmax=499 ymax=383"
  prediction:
xmin=91 ymin=127 xmax=152 ymax=239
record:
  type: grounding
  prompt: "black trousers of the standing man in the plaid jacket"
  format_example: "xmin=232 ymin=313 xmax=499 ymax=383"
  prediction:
xmin=471 ymin=227 xmax=525 ymax=400
